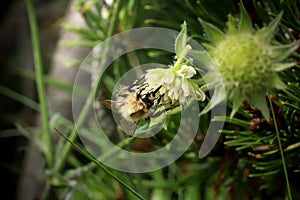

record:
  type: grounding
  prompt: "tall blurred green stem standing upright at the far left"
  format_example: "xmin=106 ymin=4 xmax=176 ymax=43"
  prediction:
xmin=25 ymin=0 xmax=53 ymax=167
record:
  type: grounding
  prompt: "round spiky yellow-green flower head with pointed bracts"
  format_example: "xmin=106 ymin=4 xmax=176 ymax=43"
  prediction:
xmin=201 ymin=6 xmax=298 ymax=119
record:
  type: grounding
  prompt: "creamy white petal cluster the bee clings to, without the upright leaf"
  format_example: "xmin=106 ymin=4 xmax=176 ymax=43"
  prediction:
xmin=145 ymin=65 xmax=205 ymax=105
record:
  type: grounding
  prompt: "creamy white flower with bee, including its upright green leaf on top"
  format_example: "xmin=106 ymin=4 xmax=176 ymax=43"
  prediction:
xmin=145 ymin=22 xmax=205 ymax=106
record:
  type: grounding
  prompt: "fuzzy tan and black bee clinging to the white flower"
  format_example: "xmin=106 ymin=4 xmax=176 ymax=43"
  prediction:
xmin=100 ymin=77 xmax=162 ymax=123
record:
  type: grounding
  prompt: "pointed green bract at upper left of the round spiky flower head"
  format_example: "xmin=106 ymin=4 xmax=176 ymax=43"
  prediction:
xmin=199 ymin=18 xmax=225 ymax=44
